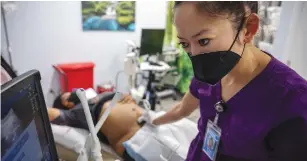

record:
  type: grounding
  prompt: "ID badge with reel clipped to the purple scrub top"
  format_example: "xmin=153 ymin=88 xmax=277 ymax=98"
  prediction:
xmin=202 ymin=101 xmax=226 ymax=161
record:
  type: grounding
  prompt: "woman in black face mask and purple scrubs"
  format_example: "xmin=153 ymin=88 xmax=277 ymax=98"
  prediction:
xmin=150 ymin=1 xmax=307 ymax=161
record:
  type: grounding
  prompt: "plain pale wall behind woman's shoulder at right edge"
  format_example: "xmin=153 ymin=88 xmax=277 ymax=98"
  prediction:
xmin=273 ymin=1 xmax=307 ymax=79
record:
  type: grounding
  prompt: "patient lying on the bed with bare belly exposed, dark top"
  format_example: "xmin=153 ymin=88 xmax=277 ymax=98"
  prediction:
xmin=48 ymin=93 xmax=148 ymax=160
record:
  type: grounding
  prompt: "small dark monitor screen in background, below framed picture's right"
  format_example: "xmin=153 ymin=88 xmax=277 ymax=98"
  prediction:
xmin=140 ymin=29 xmax=165 ymax=56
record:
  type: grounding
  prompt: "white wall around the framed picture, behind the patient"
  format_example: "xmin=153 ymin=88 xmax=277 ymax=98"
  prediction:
xmin=1 ymin=1 xmax=167 ymax=104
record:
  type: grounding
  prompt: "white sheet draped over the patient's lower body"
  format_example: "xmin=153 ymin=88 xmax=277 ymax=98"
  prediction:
xmin=124 ymin=112 xmax=197 ymax=161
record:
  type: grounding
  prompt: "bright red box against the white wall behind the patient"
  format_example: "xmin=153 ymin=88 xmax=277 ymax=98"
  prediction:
xmin=57 ymin=62 xmax=95 ymax=92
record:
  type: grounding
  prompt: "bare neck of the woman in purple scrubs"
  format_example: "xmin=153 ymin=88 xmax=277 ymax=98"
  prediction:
xmin=222 ymin=44 xmax=270 ymax=85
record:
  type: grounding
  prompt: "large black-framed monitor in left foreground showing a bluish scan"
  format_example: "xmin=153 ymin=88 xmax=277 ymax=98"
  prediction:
xmin=1 ymin=70 xmax=58 ymax=161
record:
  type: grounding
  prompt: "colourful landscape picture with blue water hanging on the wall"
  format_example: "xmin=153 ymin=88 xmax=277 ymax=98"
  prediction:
xmin=81 ymin=1 xmax=135 ymax=31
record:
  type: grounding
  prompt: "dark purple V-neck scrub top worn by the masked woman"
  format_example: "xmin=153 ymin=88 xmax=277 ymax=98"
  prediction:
xmin=187 ymin=56 xmax=307 ymax=161
